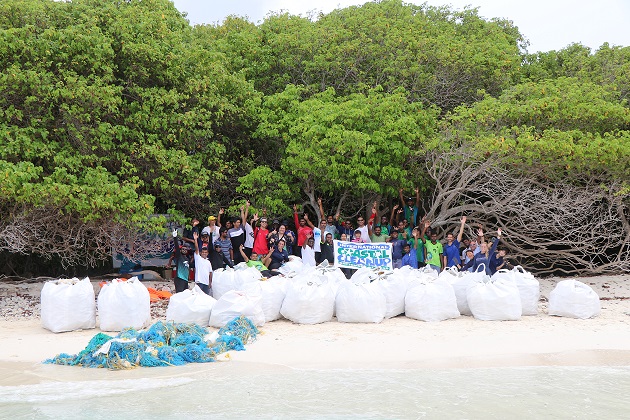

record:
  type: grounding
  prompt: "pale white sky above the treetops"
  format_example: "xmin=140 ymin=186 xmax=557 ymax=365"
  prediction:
xmin=173 ymin=0 xmax=630 ymax=53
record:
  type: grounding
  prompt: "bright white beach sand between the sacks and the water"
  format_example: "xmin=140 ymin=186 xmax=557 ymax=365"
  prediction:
xmin=0 ymin=275 xmax=630 ymax=385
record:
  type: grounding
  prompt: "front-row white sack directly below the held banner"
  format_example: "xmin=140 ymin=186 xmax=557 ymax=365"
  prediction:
xmin=335 ymin=281 xmax=387 ymax=323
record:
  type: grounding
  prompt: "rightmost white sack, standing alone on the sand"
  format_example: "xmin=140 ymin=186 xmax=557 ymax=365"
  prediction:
xmin=549 ymin=280 xmax=601 ymax=319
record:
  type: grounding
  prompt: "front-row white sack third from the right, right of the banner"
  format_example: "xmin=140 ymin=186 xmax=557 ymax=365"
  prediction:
xmin=405 ymin=278 xmax=459 ymax=322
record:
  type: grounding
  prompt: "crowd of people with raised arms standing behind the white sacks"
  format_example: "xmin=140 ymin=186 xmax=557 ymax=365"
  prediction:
xmin=167 ymin=188 xmax=507 ymax=293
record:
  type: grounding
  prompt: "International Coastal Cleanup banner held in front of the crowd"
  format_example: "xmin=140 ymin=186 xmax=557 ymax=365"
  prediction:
xmin=335 ymin=241 xmax=394 ymax=270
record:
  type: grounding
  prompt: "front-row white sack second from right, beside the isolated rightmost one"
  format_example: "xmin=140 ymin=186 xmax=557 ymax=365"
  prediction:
xmin=466 ymin=278 xmax=523 ymax=321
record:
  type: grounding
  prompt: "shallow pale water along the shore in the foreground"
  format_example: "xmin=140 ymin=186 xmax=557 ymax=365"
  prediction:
xmin=0 ymin=363 xmax=630 ymax=420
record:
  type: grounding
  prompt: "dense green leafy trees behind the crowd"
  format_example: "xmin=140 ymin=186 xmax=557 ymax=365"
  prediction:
xmin=0 ymin=0 xmax=630 ymax=274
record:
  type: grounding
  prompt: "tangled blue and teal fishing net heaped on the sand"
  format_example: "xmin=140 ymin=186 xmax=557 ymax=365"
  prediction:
xmin=44 ymin=316 xmax=258 ymax=370
